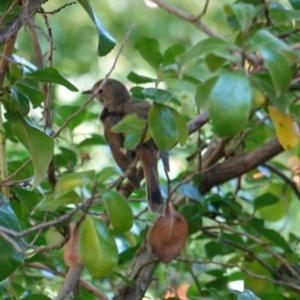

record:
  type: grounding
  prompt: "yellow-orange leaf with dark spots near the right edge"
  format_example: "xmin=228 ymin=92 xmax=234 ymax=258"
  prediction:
xmin=269 ymin=105 xmax=300 ymax=150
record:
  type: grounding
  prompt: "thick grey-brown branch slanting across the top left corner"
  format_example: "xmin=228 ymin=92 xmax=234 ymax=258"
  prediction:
xmin=0 ymin=0 xmax=47 ymax=45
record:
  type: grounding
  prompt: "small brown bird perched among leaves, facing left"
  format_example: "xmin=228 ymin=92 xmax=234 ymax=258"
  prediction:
xmin=85 ymin=79 xmax=163 ymax=213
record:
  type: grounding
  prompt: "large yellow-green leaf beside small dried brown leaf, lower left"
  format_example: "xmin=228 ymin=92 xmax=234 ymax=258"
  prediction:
xmin=79 ymin=216 xmax=118 ymax=277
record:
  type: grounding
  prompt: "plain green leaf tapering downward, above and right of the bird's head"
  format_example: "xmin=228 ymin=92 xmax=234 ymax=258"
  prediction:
xmin=134 ymin=37 xmax=163 ymax=71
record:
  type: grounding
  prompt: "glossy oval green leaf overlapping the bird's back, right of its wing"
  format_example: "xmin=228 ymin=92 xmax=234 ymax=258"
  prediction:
xmin=149 ymin=103 xmax=178 ymax=150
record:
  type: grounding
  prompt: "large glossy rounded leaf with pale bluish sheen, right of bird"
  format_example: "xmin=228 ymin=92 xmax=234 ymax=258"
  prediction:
xmin=208 ymin=71 xmax=252 ymax=137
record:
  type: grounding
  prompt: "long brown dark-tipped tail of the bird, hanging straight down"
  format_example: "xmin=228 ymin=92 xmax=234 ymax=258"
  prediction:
xmin=139 ymin=146 xmax=163 ymax=214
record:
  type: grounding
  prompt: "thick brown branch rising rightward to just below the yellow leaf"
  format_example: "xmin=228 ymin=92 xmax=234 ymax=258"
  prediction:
xmin=200 ymin=139 xmax=283 ymax=193
